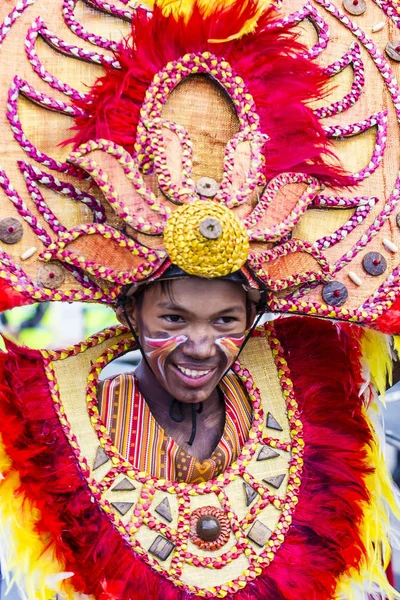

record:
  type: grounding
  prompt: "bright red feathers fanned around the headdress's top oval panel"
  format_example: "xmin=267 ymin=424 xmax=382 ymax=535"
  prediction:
xmin=73 ymin=0 xmax=348 ymax=185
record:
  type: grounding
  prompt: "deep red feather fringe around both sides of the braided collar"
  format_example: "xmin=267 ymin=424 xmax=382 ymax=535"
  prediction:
xmin=0 ymin=317 xmax=371 ymax=600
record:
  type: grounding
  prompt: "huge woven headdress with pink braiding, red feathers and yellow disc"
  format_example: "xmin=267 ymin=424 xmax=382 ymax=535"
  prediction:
xmin=0 ymin=0 xmax=400 ymax=331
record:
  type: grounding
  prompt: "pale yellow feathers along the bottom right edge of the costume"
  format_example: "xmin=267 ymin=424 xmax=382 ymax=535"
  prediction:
xmin=336 ymin=414 xmax=400 ymax=600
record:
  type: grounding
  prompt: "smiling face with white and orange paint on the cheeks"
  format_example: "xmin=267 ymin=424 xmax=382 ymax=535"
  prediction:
xmin=119 ymin=277 xmax=249 ymax=403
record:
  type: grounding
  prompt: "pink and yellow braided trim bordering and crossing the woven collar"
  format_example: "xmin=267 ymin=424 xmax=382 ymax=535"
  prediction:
xmin=42 ymin=324 xmax=304 ymax=598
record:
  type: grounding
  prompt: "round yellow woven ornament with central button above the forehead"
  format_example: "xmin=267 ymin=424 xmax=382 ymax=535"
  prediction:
xmin=164 ymin=200 xmax=249 ymax=277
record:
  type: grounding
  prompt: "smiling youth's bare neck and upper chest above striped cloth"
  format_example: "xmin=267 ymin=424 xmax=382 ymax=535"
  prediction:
xmin=135 ymin=360 xmax=225 ymax=461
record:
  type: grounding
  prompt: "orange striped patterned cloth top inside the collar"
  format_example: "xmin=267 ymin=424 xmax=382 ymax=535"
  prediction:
xmin=100 ymin=373 xmax=252 ymax=483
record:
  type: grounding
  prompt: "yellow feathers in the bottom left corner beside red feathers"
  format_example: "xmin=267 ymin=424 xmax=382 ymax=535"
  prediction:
xmin=0 ymin=439 xmax=79 ymax=600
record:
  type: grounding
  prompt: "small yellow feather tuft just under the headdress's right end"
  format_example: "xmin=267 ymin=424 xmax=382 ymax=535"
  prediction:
xmin=361 ymin=329 xmax=393 ymax=399
